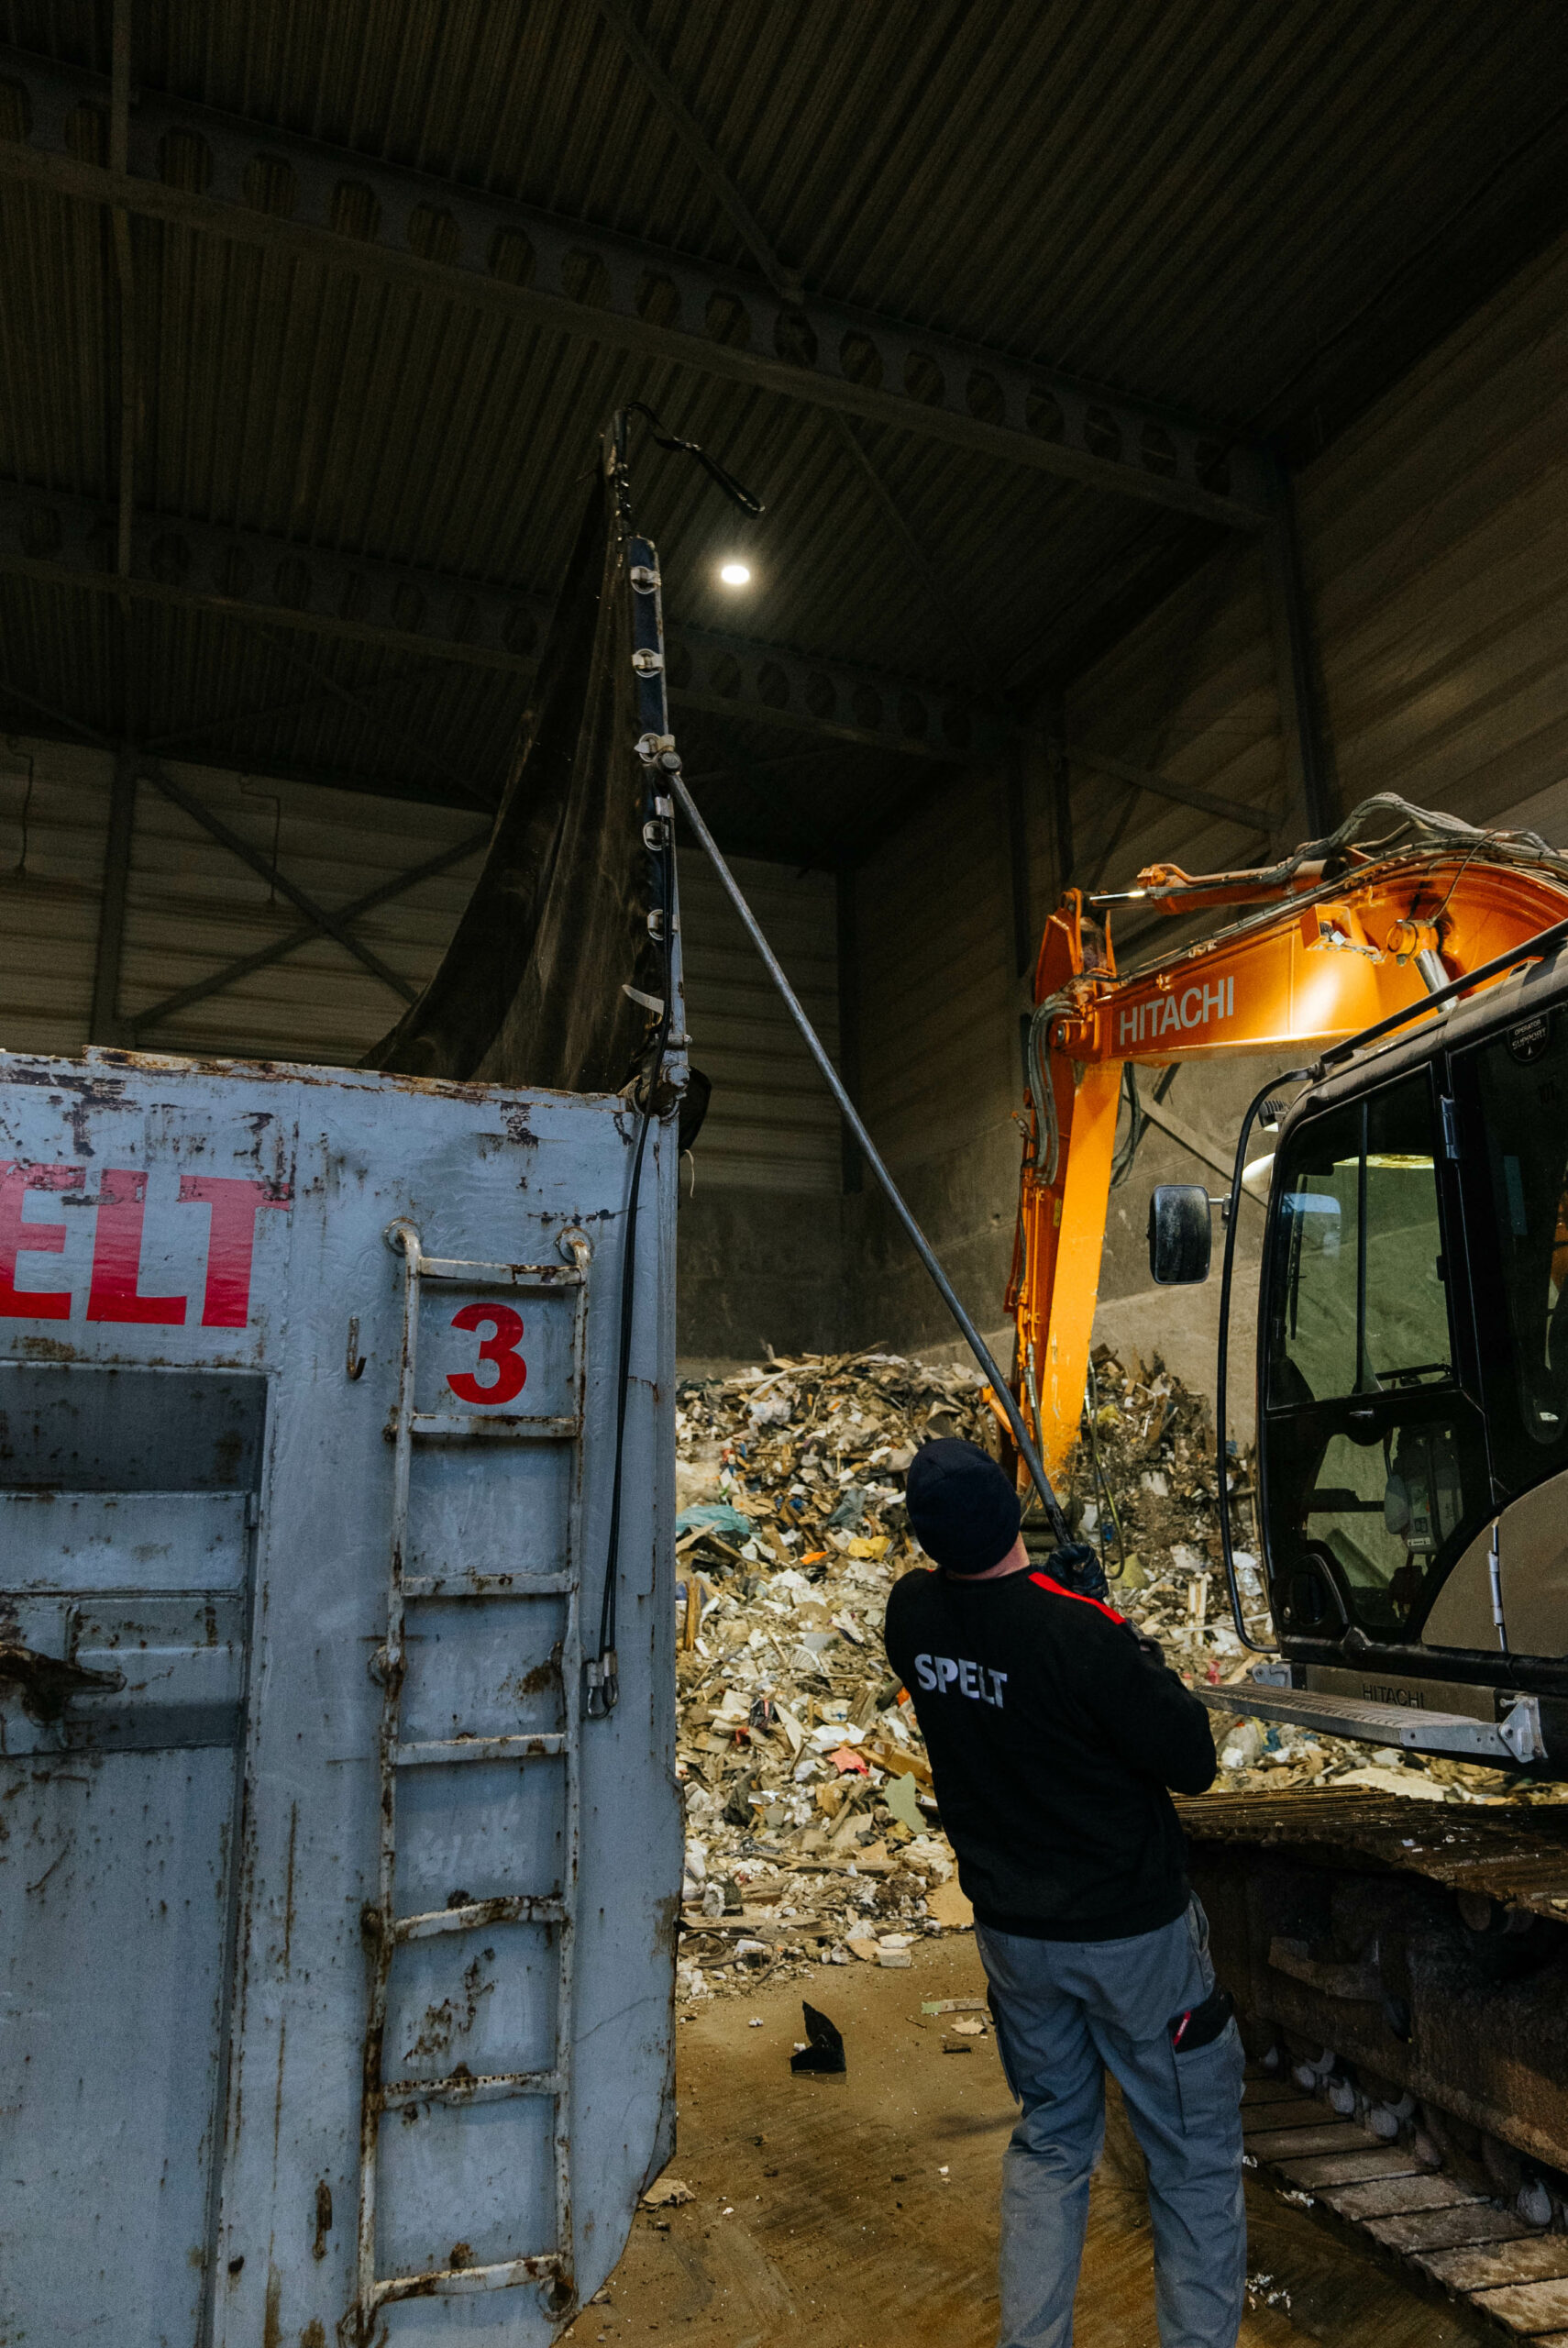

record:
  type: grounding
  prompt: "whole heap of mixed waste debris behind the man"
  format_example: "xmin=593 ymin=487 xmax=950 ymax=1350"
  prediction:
xmin=676 ymin=1347 xmax=1528 ymax=2003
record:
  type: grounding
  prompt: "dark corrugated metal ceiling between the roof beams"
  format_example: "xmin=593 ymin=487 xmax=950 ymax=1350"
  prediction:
xmin=0 ymin=0 xmax=1568 ymax=855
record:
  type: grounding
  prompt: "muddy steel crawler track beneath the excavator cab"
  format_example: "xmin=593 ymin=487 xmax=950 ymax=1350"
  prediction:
xmin=1178 ymin=1791 xmax=1568 ymax=2348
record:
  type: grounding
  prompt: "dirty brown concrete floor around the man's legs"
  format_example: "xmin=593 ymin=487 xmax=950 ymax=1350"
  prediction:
xmin=566 ymin=1937 xmax=1479 ymax=2348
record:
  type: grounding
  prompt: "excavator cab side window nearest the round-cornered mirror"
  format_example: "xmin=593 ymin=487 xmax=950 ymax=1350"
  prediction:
xmin=1263 ymin=1070 xmax=1485 ymax=1639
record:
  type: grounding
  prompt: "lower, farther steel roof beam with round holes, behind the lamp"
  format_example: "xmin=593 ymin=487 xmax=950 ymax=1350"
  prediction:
xmin=0 ymin=483 xmax=1007 ymax=766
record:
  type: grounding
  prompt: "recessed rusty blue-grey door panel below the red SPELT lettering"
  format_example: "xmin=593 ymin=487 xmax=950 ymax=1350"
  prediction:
xmin=0 ymin=1364 xmax=265 ymax=2348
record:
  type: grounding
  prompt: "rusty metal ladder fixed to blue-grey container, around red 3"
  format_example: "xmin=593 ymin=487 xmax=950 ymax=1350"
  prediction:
xmin=355 ymin=1221 xmax=591 ymax=2348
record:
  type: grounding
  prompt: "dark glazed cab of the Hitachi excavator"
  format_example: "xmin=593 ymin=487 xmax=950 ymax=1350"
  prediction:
xmin=1258 ymin=968 xmax=1568 ymax=1768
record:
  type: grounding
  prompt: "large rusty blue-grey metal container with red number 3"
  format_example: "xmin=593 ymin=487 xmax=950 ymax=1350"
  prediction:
xmin=0 ymin=1052 xmax=680 ymax=2348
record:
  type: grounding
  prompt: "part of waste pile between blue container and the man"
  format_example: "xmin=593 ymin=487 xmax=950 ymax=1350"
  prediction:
xmin=676 ymin=1355 xmax=995 ymax=1999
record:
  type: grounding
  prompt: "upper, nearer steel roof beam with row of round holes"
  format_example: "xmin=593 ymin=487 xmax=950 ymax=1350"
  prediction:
xmin=0 ymin=50 xmax=1270 ymax=528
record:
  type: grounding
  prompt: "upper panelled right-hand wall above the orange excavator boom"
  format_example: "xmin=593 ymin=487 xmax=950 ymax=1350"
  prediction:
xmin=1068 ymin=224 xmax=1568 ymax=929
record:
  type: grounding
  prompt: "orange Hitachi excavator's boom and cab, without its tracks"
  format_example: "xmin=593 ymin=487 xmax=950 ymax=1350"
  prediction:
xmin=1007 ymin=793 xmax=1568 ymax=1775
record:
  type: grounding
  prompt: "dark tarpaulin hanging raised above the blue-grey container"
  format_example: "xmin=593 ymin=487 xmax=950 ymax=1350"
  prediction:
xmin=364 ymin=474 xmax=662 ymax=1091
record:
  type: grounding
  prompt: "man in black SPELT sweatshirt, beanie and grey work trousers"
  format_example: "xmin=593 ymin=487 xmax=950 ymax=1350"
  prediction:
xmin=885 ymin=1439 xmax=1246 ymax=2348
